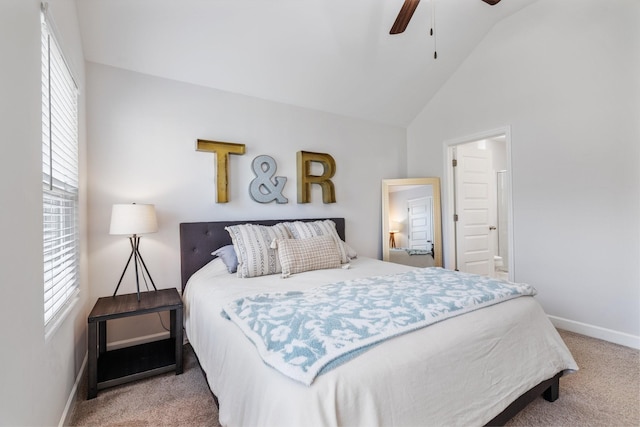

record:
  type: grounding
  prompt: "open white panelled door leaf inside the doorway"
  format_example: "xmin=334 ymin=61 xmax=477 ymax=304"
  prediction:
xmin=454 ymin=143 xmax=495 ymax=276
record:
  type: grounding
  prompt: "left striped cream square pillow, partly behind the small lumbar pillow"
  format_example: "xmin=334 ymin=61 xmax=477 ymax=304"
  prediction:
xmin=225 ymin=224 xmax=291 ymax=278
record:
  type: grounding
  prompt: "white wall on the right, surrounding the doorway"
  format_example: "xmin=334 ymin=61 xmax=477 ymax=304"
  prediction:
xmin=407 ymin=0 xmax=640 ymax=346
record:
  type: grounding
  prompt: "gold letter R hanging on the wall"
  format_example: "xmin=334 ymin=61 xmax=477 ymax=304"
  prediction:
xmin=297 ymin=151 xmax=336 ymax=203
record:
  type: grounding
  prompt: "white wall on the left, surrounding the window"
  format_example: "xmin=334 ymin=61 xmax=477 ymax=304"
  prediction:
xmin=0 ymin=0 xmax=88 ymax=426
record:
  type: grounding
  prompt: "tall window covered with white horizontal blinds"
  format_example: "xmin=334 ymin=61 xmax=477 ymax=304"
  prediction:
xmin=42 ymin=12 xmax=79 ymax=326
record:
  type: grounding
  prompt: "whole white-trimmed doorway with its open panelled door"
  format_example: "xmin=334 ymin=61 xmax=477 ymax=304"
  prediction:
xmin=445 ymin=128 xmax=514 ymax=280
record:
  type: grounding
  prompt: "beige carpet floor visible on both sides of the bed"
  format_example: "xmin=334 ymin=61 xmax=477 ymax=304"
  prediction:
xmin=70 ymin=331 xmax=640 ymax=427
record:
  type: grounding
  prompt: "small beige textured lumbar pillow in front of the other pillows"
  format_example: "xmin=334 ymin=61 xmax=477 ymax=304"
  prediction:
xmin=272 ymin=236 xmax=340 ymax=277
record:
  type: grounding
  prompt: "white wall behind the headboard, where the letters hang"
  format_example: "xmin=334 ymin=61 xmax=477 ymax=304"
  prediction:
xmin=87 ymin=63 xmax=406 ymax=343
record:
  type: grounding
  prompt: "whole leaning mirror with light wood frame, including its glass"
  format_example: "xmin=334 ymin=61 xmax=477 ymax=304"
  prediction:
xmin=382 ymin=178 xmax=442 ymax=267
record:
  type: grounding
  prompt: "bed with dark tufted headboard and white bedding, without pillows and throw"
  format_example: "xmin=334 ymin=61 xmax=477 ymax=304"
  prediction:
xmin=180 ymin=218 xmax=578 ymax=426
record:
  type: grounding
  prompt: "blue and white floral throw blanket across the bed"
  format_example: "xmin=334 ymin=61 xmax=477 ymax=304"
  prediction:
xmin=222 ymin=268 xmax=536 ymax=385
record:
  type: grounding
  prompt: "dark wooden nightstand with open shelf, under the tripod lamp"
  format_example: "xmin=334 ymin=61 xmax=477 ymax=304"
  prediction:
xmin=87 ymin=288 xmax=182 ymax=399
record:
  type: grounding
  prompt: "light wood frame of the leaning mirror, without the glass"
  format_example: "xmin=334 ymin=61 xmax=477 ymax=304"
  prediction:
xmin=382 ymin=177 xmax=443 ymax=267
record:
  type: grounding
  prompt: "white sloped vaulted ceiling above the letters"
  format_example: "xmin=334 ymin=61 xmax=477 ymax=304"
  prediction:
xmin=76 ymin=0 xmax=536 ymax=127
